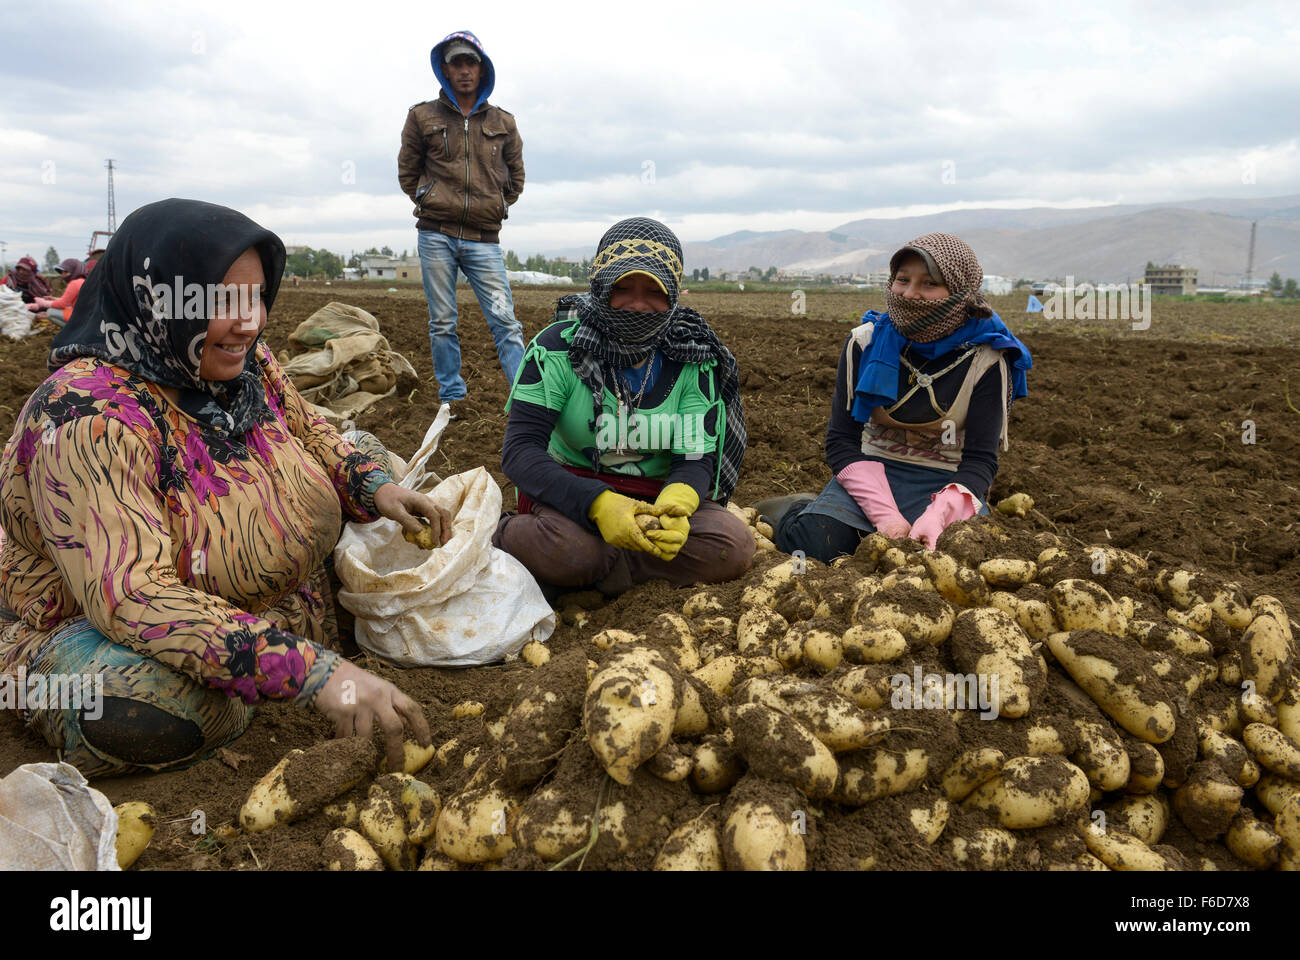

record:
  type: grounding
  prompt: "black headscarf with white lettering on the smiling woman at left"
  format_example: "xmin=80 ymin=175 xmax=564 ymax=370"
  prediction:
xmin=49 ymin=199 xmax=285 ymax=437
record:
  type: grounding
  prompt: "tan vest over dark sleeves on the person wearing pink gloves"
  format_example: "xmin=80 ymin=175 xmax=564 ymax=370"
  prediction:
xmin=845 ymin=321 xmax=1008 ymax=472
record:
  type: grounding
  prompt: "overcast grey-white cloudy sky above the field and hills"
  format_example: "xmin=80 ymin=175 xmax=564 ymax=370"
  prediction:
xmin=0 ymin=0 xmax=1300 ymax=263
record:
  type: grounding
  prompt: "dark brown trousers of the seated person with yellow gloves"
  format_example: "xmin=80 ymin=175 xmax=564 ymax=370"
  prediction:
xmin=491 ymin=501 xmax=754 ymax=594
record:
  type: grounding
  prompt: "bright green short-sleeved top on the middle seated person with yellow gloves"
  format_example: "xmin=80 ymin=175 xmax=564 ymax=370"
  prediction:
xmin=506 ymin=313 xmax=727 ymax=494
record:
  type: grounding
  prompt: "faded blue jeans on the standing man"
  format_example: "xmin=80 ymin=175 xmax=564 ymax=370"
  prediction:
xmin=416 ymin=230 xmax=524 ymax=403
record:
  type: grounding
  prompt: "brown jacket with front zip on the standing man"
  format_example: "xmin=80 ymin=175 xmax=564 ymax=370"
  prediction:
xmin=398 ymin=92 xmax=524 ymax=243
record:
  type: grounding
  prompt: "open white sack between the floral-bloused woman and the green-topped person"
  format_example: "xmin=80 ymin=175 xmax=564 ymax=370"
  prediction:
xmin=334 ymin=405 xmax=555 ymax=666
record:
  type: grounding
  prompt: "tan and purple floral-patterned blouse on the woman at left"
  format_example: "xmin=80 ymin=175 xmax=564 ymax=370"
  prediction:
xmin=0 ymin=345 xmax=389 ymax=704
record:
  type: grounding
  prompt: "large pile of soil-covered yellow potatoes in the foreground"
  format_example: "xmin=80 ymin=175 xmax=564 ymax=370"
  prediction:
xmin=228 ymin=502 xmax=1300 ymax=870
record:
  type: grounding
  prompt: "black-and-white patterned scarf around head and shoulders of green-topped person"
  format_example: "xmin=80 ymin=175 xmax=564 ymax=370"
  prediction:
xmin=558 ymin=217 xmax=748 ymax=502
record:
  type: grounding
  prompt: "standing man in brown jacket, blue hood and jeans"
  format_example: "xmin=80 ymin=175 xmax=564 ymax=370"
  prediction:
xmin=398 ymin=30 xmax=524 ymax=419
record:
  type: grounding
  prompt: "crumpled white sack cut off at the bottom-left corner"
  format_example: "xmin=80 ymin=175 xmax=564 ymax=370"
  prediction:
xmin=0 ymin=764 xmax=118 ymax=870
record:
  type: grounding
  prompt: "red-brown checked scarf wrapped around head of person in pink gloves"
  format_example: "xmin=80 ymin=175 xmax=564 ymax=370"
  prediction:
xmin=885 ymin=233 xmax=993 ymax=343
